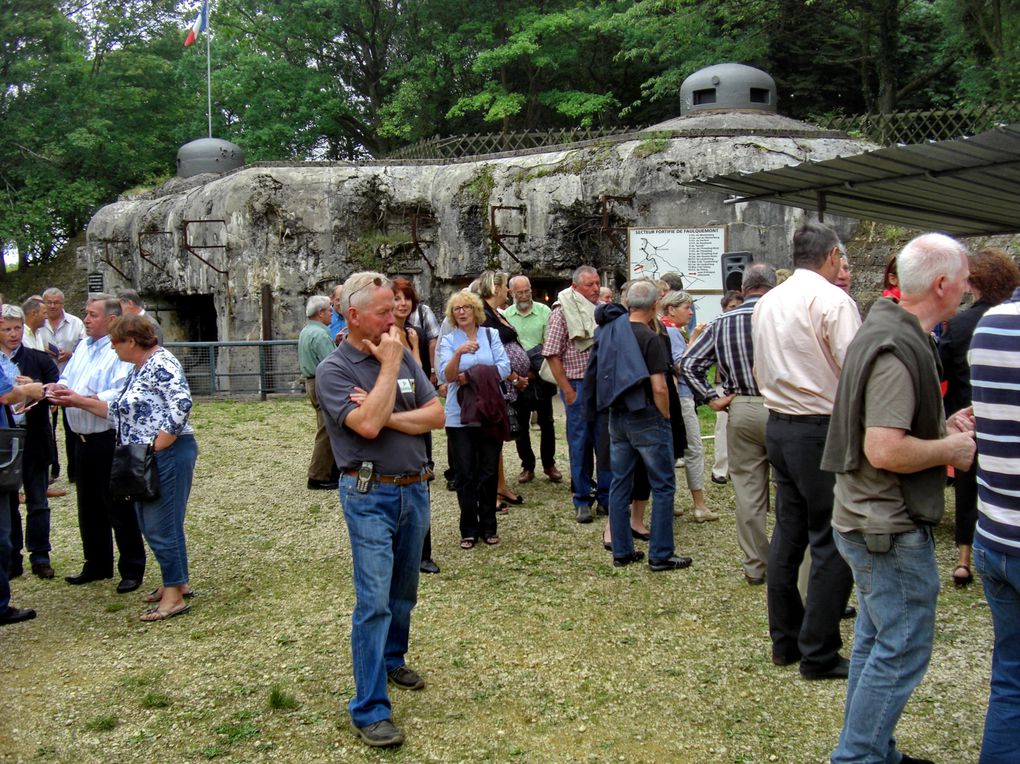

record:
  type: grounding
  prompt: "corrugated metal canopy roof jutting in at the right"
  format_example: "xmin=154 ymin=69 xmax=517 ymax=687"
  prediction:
xmin=685 ymin=124 xmax=1020 ymax=236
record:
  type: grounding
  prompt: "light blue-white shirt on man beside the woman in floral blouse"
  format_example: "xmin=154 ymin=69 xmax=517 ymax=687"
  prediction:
xmin=58 ymin=335 xmax=134 ymax=436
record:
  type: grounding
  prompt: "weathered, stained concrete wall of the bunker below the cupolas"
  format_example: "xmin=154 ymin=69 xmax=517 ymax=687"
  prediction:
xmin=81 ymin=112 xmax=872 ymax=340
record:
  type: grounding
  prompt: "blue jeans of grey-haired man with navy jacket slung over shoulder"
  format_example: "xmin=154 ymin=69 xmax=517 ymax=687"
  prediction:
xmin=609 ymin=406 xmax=676 ymax=560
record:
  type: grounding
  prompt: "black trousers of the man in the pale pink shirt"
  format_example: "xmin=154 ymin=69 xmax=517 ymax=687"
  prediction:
xmin=765 ymin=412 xmax=853 ymax=672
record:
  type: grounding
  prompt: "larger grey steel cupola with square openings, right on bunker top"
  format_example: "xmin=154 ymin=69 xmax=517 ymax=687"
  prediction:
xmin=680 ymin=63 xmax=778 ymax=116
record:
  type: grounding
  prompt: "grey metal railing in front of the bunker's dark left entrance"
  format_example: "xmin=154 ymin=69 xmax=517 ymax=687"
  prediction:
xmin=164 ymin=340 xmax=305 ymax=400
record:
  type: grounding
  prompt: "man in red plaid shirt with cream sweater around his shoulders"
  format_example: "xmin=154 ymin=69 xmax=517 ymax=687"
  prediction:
xmin=543 ymin=265 xmax=610 ymax=522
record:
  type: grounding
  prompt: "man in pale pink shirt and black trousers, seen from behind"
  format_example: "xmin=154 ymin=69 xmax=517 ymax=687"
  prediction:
xmin=752 ymin=222 xmax=861 ymax=679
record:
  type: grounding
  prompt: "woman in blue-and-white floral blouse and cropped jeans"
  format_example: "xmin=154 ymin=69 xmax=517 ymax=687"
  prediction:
xmin=52 ymin=315 xmax=198 ymax=621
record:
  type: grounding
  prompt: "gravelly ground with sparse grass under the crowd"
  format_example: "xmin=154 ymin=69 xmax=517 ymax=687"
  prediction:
xmin=0 ymin=400 xmax=991 ymax=763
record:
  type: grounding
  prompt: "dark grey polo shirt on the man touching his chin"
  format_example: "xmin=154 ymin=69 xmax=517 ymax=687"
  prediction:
xmin=315 ymin=342 xmax=436 ymax=475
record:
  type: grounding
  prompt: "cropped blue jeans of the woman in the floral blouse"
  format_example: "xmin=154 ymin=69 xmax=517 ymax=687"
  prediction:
xmin=135 ymin=435 xmax=198 ymax=587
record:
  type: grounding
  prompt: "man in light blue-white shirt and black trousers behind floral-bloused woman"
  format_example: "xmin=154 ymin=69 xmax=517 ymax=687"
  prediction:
xmin=51 ymin=294 xmax=145 ymax=594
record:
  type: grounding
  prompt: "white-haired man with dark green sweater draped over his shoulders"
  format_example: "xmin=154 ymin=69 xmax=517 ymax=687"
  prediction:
xmin=812 ymin=234 xmax=975 ymax=764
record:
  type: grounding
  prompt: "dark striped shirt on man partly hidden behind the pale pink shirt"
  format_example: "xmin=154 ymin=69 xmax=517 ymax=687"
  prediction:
xmin=680 ymin=296 xmax=761 ymax=400
